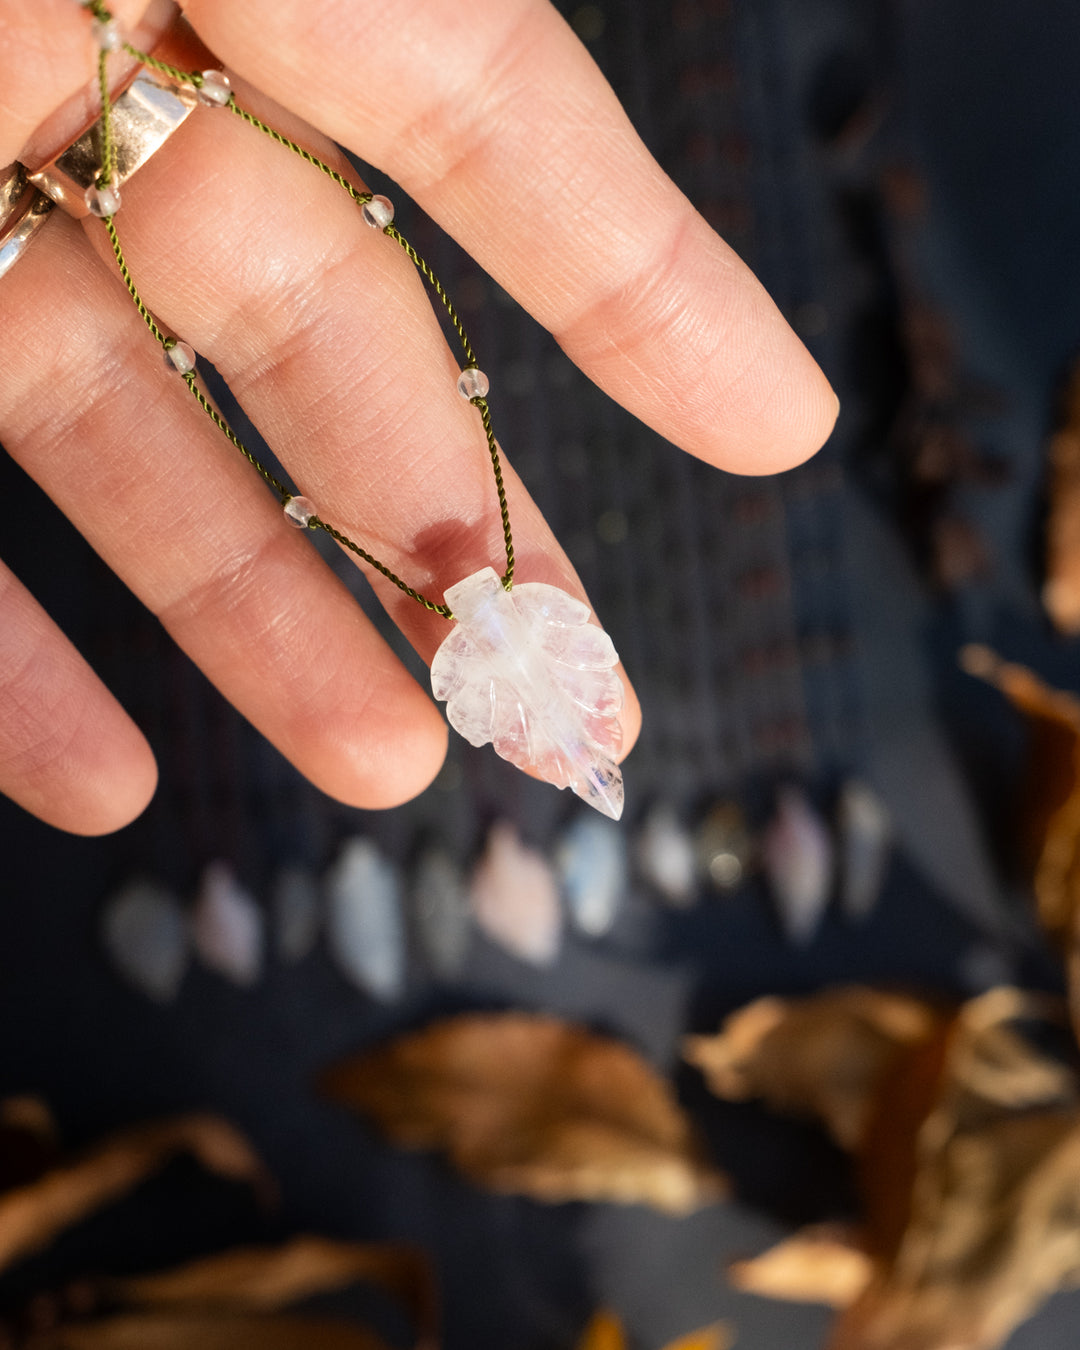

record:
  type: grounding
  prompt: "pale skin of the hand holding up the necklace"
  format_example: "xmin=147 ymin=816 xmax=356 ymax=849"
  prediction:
xmin=0 ymin=0 xmax=837 ymax=834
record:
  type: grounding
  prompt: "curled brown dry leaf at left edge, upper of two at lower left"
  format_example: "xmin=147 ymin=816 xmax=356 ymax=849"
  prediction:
xmin=0 ymin=1115 xmax=270 ymax=1270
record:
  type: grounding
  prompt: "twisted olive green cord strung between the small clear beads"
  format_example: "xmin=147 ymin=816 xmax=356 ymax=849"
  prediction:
xmin=85 ymin=0 xmax=514 ymax=620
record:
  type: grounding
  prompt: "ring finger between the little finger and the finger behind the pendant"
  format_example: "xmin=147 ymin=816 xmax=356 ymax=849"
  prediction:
xmin=0 ymin=199 xmax=446 ymax=806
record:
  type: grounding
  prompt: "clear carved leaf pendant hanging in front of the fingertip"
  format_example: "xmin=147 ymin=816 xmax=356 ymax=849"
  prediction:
xmin=431 ymin=567 xmax=622 ymax=821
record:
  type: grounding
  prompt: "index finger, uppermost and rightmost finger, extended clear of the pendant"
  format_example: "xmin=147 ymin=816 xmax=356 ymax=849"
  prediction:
xmin=182 ymin=0 xmax=838 ymax=474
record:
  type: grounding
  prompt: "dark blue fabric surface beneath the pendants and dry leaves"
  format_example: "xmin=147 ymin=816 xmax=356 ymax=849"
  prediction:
xmin=0 ymin=0 xmax=1080 ymax=1350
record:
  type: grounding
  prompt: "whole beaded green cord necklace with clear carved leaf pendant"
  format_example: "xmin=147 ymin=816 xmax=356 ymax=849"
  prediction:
xmin=63 ymin=0 xmax=622 ymax=819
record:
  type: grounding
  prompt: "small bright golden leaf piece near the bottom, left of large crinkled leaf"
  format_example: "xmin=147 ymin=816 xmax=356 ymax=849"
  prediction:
xmin=728 ymin=1226 xmax=873 ymax=1308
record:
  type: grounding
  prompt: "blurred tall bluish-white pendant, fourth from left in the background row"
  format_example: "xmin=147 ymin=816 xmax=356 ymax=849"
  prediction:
xmin=325 ymin=838 xmax=405 ymax=1003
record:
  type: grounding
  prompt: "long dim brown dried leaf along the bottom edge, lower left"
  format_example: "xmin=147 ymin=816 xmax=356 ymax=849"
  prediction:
xmin=103 ymin=1237 xmax=439 ymax=1345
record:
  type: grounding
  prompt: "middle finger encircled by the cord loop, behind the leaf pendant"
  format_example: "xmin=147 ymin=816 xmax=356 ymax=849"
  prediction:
xmin=2 ymin=29 xmax=637 ymax=805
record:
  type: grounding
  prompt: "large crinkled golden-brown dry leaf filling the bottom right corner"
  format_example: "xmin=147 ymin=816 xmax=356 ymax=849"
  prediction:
xmin=829 ymin=990 xmax=1080 ymax=1350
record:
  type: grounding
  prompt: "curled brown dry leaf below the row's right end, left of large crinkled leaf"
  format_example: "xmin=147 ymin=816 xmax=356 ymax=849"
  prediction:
xmin=683 ymin=986 xmax=941 ymax=1150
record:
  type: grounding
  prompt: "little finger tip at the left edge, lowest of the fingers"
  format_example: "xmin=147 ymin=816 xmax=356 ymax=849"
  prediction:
xmin=0 ymin=550 xmax=157 ymax=834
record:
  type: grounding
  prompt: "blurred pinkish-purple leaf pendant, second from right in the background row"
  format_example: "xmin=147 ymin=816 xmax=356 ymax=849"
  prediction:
xmin=760 ymin=786 xmax=834 ymax=946
